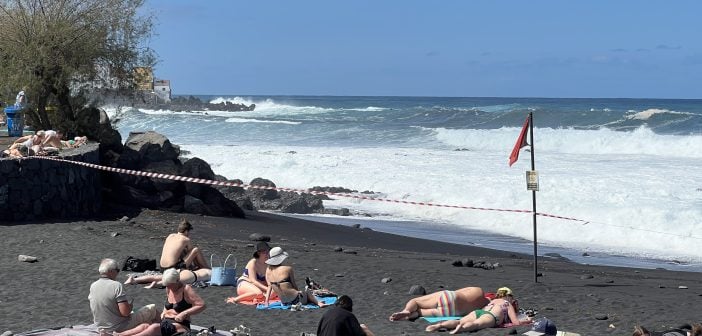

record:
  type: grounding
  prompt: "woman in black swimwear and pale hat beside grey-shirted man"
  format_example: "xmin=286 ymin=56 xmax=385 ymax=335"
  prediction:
xmin=117 ymin=268 xmax=205 ymax=336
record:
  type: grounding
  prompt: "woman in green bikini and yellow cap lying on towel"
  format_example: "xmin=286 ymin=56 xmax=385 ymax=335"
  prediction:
xmin=426 ymin=287 xmax=519 ymax=334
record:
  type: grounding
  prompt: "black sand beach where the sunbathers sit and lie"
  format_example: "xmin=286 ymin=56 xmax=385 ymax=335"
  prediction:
xmin=0 ymin=210 xmax=702 ymax=335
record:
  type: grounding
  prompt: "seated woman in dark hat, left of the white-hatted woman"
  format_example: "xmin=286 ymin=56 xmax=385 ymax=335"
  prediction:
xmin=226 ymin=242 xmax=271 ymax=303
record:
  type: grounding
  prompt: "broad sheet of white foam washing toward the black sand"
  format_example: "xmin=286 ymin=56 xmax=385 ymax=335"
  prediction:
xmin=184 ymin=145 xmax=702 ymax=260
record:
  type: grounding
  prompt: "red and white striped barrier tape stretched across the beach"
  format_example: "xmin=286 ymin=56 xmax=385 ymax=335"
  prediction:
xmin=29 ymin=156 xmax=588 ymax=224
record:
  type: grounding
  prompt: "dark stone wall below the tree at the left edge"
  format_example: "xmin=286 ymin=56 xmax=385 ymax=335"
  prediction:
xmin=0 ymin=143 xmax=102 ymax=222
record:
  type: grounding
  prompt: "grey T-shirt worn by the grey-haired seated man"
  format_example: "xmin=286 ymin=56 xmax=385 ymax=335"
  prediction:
xmin=88 ymin=278 xmax=130 ymax=332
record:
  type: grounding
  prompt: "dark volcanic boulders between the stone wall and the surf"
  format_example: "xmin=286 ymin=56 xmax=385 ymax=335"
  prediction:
xmin=98 ymin=132 xmax=355 ymax=218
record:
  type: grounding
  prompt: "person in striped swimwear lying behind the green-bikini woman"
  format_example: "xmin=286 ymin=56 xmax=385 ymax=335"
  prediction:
xmin=390 ymin=287 xmax=490 ymax=321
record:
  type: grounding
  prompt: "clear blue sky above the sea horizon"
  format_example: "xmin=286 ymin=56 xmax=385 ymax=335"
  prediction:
xmin=145 ymin=0 xmax=702 ymax=99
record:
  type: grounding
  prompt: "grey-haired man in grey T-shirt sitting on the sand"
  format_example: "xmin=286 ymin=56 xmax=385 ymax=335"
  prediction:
xmin=88 ymin=259 xmax=160 ymax=334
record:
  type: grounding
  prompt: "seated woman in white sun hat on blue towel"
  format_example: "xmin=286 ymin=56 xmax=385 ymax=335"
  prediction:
xmin=265 ymin=247 xmax=325 ymax=307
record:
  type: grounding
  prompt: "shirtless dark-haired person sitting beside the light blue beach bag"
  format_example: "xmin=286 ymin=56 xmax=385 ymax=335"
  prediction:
xmin=124 ymin=219 xmax=212 ymax=288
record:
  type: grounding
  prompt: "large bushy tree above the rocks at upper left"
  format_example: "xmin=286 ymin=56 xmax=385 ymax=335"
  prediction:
xmin=0 ymin=0 xmax=155 ymax=134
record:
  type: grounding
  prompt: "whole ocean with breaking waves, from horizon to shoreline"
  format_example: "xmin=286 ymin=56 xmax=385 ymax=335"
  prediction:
xmin=107 ymin=95 xmax=702 ymax=271
